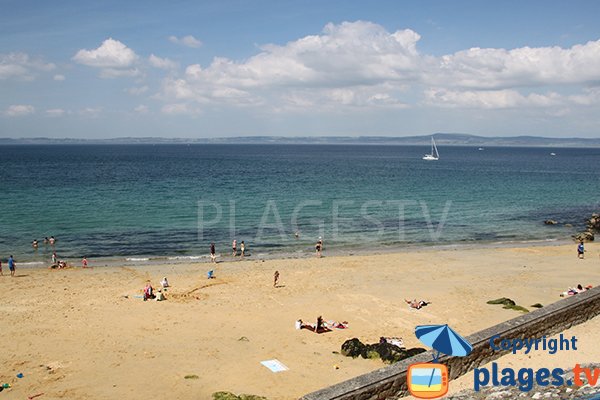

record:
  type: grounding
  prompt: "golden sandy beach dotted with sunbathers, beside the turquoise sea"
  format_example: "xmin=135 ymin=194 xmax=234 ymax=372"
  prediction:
xmin=0 ymin=244 xmax=600 ymax=400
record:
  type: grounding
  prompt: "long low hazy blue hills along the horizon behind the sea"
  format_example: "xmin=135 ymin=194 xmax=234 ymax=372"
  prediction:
xmin=0 ymin=133 xmax=600 ymax=147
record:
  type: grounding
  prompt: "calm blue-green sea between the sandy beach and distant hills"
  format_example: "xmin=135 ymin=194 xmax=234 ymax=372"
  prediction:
xmin=0 ymin=144 xmax=600 ymax=266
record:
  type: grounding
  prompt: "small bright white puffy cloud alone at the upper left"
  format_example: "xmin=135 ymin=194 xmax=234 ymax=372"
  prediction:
xmin=73 ymin=38 xmax=138 ymax=68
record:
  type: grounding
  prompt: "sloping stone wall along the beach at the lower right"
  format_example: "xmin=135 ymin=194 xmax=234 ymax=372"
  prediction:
xmin=301 ymin=287 xmax=600 ymax=400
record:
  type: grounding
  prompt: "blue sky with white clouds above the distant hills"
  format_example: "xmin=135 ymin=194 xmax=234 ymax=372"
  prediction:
xmin=0 ymin=0 xmax=600 ymax=139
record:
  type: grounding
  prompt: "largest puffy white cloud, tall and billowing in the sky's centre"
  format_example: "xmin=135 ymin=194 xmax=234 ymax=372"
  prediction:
xmin=162 ymin=21 xmax=422 ymax=107
